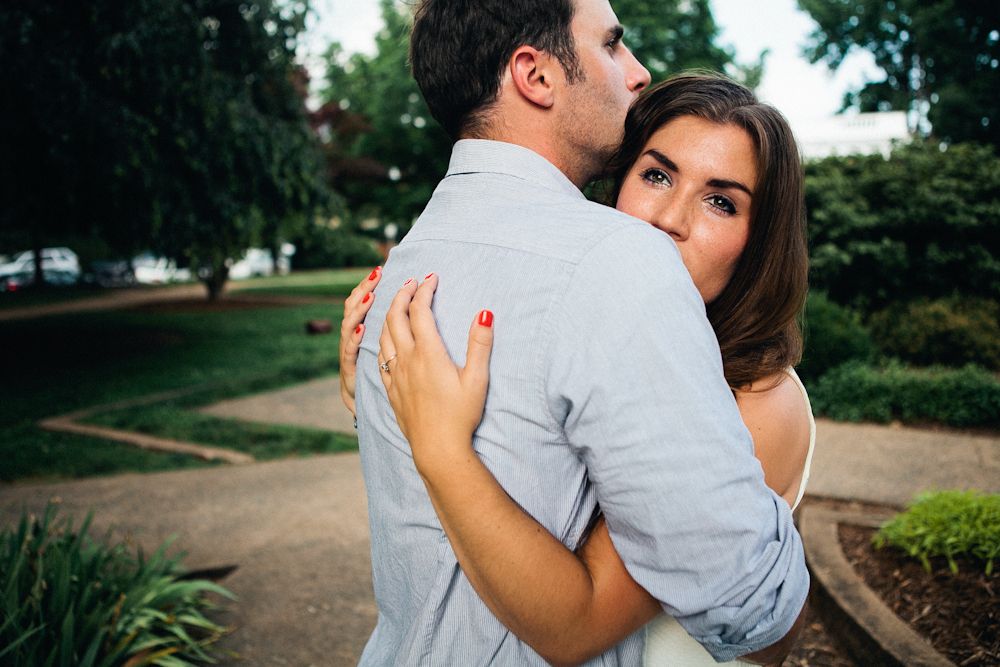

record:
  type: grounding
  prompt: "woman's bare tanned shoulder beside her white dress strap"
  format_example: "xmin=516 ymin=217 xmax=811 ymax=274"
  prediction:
xmin=736 ymin=371 xmax=810 ymax=505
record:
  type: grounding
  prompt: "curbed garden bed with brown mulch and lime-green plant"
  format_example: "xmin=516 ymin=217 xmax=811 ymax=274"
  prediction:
xmin=794 ymin=491 xmax=1000 ymax=667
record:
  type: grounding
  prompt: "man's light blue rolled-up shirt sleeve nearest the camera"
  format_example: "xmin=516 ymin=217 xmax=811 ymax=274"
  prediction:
xmin=544 ymin=224 xmax=809 ymax=660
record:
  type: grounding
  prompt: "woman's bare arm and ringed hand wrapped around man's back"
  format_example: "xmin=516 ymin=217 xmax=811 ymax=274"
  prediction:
xmin=379 ymin=276 xmax=801 ymax=664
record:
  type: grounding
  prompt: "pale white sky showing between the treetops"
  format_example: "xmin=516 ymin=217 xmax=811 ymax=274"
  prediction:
xmin=307 ymin=0 xmax=878 ymax=126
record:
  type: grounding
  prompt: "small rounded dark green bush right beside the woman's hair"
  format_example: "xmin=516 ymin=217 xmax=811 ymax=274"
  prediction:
xmin=798 ymin=292 xmax=875 ymax=379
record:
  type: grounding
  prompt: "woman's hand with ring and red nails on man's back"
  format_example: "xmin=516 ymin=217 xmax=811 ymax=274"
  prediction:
xmin=379 ymin=274 xmax=493 ymax=474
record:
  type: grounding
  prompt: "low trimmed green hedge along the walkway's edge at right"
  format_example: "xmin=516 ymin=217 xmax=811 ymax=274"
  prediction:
xmin=809 ymin=362 xmax=1000 ymax=427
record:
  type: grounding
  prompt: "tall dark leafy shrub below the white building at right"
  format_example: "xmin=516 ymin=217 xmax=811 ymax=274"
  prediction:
xmin=805 ymin=141 xmax=1000 ymax=315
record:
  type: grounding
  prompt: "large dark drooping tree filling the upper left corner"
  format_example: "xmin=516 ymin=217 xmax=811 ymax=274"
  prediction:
xmin=0 ymin=0 xmax=327 ymax=298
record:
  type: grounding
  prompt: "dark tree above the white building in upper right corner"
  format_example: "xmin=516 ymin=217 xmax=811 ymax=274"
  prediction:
xmin=799 ymin=0 xmax=1000 ymax=145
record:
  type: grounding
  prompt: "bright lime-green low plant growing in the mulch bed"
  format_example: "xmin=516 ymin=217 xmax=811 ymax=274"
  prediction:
xmin=873 ymin=491 xmax=1000 ymax=574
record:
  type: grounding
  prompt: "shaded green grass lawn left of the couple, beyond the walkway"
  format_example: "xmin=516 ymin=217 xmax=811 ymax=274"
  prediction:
xmin=0 ymin=296 xmax=360 ymax=481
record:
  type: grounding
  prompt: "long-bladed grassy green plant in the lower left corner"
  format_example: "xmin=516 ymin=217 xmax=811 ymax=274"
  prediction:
xmin=0 ymin=505 xmax=233 ymax=667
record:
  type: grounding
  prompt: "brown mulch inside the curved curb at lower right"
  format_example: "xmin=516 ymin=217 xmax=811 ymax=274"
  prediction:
xmin=840 ymin=525 xmax=1000 ymax=667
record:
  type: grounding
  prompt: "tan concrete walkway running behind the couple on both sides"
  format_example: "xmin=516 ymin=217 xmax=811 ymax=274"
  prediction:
xmin=0 ymin=378 xmax=1000 ymax=666
